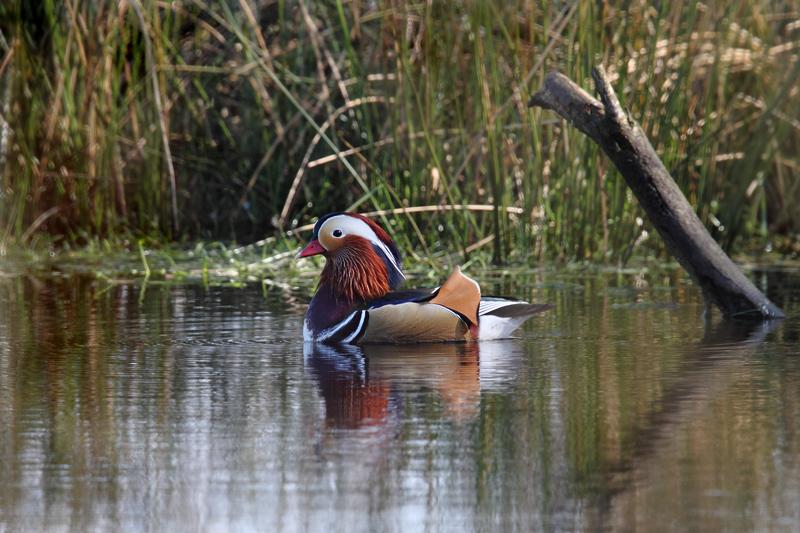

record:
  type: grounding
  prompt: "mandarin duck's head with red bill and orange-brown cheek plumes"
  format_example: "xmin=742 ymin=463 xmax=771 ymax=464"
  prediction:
xmin=297 ymin=213 xmax=405 ymax=303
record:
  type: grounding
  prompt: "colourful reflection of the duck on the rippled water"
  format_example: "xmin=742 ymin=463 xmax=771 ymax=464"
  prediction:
xmin=304 ymin=340 xmax=523 ymax=428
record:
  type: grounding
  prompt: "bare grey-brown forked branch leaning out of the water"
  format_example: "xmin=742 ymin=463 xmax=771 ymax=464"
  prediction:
xmin=529 ymin=67 xmax=785 ymax=319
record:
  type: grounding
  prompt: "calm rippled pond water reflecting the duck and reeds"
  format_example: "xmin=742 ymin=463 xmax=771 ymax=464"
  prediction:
xmin=0 ymin=271 xmax=800 ymax=532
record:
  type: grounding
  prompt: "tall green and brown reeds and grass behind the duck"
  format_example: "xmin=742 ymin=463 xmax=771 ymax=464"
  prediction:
xmin=0 ymin=0 xmax=800 ymax=262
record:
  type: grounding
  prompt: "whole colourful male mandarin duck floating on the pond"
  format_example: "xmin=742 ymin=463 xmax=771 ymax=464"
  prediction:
xmin=297 ymin=213 xmax=552 ymax=344
